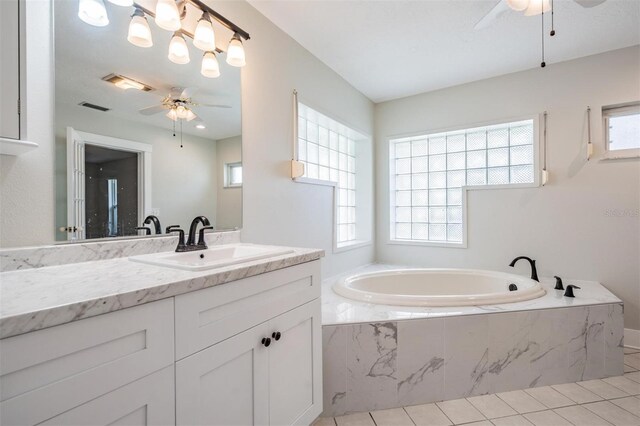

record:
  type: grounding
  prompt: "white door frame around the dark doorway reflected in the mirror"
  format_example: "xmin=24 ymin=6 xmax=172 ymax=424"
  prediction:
xmin=67 ymin=127 xmax=153 ymax=240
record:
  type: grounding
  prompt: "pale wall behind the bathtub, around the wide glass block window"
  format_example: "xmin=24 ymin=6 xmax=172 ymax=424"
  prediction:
xmin=376 ymin=46 xmax=640 ymax=329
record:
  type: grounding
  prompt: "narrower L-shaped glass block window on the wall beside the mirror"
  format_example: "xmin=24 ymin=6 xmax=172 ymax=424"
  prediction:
xmin=297 ymin=103 xmax=363 ymax=244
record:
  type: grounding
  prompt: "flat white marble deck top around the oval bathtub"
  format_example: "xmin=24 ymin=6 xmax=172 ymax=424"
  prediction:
xmin=322 ymin=264 xmax=622 ymax=325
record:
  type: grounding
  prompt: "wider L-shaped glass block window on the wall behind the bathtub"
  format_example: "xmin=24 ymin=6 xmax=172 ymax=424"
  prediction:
xmin=389 ymin=120 xmax=535 ymax=244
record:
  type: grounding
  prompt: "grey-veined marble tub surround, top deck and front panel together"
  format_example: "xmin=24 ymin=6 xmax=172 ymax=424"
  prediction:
xmin=322 ymin=265 xmax=624 ymax=416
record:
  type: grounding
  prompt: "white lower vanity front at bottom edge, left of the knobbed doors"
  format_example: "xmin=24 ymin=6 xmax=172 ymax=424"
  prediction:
xmin=40 ymin=366 xmax=175 ymax=426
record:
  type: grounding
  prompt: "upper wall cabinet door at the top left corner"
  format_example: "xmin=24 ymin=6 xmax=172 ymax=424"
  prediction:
xmin=0 ymin=0 xmax=20 ymax=139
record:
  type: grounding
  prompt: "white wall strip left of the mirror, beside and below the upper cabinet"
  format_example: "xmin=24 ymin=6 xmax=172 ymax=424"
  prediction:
xmin=0 ymin=0 xmax=54 ymax=247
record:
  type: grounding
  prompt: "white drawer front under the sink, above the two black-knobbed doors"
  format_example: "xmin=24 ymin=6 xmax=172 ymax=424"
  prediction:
xmin=176 ymin=261 xmax=320 ymax=359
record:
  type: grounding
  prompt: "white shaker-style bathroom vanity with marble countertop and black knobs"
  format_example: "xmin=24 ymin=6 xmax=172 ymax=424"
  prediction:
xmin=0 ymin=238 xmax=323 ymax=425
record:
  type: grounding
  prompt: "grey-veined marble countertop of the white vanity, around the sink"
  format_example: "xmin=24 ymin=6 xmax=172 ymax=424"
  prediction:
xmin=0 ymin=246 xmax=324 ymax=338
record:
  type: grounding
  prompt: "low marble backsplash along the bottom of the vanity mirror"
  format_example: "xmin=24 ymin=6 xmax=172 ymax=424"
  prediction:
xmin=0 ymin=231 xmax=240 ymax=272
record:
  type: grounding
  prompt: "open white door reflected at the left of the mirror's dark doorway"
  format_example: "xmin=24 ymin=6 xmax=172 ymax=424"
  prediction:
xmin=67 ymin=127 xmax=86 ymax=240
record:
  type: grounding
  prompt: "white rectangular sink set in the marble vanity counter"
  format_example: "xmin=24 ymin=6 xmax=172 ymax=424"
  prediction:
xmin=129 ymin=244 xmax=293 ymax=271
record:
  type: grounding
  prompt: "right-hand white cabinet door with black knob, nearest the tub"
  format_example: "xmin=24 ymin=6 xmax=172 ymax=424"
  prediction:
xmin=269 ymin=299 xmax=322 ymax=425
